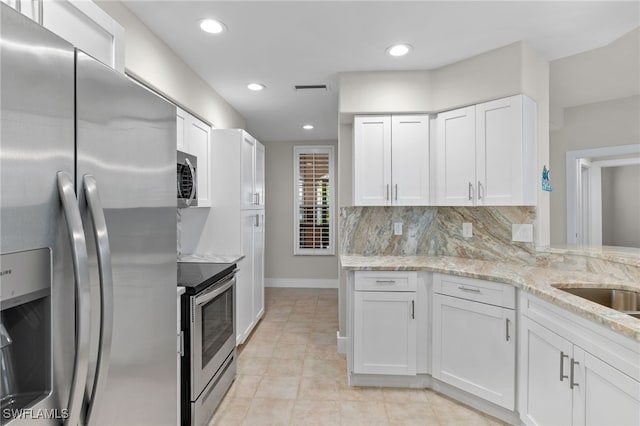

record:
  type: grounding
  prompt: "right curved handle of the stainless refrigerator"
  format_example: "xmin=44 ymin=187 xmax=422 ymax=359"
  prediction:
xmin=82 ymin=175 xmax=113 ymax=424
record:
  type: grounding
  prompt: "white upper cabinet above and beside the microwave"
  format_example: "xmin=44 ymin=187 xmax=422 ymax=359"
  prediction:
xmin=176 ymin=108 xmax=211 ymax=207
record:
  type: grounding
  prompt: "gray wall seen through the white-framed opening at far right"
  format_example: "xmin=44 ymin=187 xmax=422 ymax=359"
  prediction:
xmin=602 ymin=164 xmax=640 ymax=248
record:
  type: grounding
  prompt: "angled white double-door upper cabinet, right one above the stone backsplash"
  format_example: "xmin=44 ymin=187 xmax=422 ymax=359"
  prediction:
xmin=435 ymin=95 xmax=537 ymax=206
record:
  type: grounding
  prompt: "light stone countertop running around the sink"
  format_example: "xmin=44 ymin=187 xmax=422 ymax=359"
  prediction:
xmin=340 ymin=255 xmax=640 ymax=341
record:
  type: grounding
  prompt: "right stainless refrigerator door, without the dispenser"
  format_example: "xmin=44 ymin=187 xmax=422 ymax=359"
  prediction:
xmin=76 ymin=51 xmax=178 ymax=425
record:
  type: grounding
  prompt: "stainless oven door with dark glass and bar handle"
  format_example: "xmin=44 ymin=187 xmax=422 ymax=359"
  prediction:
xmin=191 ymin=273 xmax=236 ymax=401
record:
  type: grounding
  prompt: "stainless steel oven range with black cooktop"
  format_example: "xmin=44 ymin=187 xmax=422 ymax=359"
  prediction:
xmin=178 ymin=262 xmax=237 ymax=425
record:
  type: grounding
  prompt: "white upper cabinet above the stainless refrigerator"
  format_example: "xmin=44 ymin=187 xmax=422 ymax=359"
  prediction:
xmin=2 ymin=0 xmax=125 ymax=73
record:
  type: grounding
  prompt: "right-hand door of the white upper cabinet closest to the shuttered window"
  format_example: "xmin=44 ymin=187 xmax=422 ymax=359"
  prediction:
xmin=391 ymin=115 xmax=429 ymax=206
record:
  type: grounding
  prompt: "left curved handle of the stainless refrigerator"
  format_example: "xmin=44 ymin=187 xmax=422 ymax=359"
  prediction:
xmin=57 ymin=171 xmax=91 ymax=426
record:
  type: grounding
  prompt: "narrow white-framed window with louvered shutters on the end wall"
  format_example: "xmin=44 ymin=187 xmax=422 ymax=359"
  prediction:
xmin=293 ymin=145 xmax=335 ymax=255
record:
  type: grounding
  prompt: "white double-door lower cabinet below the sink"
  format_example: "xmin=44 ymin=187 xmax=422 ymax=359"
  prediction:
xmin=519 ymin=292 xmax=640 ymax=426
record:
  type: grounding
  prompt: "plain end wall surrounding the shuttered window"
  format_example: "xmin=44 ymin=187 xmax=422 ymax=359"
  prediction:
xmin=264 ymin=141 xmax=339 ymax=280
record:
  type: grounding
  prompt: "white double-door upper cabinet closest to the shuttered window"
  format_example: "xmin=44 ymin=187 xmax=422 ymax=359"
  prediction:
xmin=353 ymin=115 xmax=429 ymax=206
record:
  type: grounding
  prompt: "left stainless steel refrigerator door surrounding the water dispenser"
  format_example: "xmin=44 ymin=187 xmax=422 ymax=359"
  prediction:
xmin=0 ymin=3 xmax=75 ymax=425
